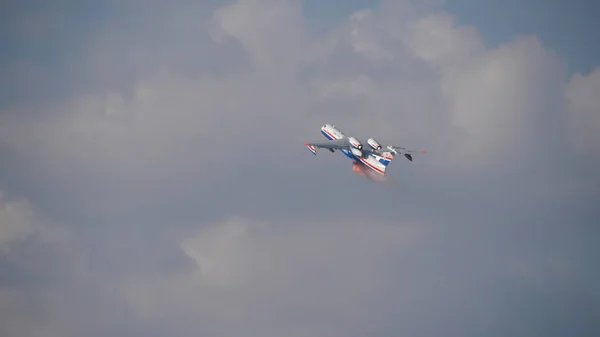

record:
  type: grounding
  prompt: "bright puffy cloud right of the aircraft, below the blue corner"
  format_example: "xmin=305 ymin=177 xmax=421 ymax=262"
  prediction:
xmin=442 ymin=37 xmax=563 ymax=164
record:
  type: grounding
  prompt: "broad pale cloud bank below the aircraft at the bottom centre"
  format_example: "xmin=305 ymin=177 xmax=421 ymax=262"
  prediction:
xmin=126 ymin=218 xmax=426 ymax=336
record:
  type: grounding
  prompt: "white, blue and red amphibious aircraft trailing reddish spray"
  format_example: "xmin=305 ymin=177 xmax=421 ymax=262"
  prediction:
xmin=304 ymin=124 xmax=427 ymax=180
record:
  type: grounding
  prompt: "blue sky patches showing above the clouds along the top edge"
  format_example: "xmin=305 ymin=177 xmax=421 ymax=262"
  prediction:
xmin=0 ymin=0 xmax=600 ymax=109
